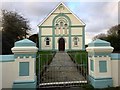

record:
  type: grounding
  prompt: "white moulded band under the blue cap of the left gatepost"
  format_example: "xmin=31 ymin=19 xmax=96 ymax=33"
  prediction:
xmin=11 ymin=46 xmax=38 ymax=53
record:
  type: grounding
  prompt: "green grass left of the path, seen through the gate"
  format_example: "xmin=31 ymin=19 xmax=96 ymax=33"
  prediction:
xmin=36 ymin=52 xmax=55 ymax=84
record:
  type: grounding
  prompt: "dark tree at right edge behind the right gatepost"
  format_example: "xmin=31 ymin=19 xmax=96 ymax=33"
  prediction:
xmin=93 ymin=24 xmax=120 ymax=52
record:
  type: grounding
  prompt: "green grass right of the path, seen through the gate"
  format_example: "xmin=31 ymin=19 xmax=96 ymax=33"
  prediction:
xmin=67 ymin=51 xmax=88 ymax=79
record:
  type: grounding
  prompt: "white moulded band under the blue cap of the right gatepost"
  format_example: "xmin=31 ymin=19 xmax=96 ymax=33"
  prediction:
xmin=86 ymin=46 xmax=114 ymax=53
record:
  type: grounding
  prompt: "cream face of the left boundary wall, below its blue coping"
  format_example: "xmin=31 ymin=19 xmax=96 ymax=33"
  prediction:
xmin=2 ymin=62 xmax=17 ymax=88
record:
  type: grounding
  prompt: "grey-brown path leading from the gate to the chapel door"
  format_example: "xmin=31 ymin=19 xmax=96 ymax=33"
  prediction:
xmin=42 ymin=52 xmax=85 ymax=83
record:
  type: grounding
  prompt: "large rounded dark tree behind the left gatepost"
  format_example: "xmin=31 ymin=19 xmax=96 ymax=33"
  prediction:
xmin=2 ymin=10 xmax=31 ymax=54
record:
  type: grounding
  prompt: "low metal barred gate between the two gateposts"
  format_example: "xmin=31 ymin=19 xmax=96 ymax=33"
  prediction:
xmin=36 ymin=52 xmax=88 ymax=88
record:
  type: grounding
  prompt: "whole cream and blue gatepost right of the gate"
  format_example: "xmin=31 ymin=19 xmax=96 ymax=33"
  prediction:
xmin=86 ymin=39 xmax=114 ymax=88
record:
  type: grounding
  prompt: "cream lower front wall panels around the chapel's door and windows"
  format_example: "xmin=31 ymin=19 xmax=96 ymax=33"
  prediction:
xmin=41 ymin=36 xmax=83 ymax=51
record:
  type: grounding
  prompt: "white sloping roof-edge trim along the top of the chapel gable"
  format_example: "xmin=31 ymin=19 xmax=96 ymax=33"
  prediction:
xmin=38 ymin=2 xmax=86 ymax=26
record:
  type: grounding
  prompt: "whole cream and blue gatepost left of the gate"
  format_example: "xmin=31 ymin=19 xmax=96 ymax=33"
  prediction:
xmin=12 ymin=39 xmax=38 ymax=90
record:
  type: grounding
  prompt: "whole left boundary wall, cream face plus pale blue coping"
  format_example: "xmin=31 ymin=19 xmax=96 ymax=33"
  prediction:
xmin=0 ymin=55 xmax=17 ymax=88
